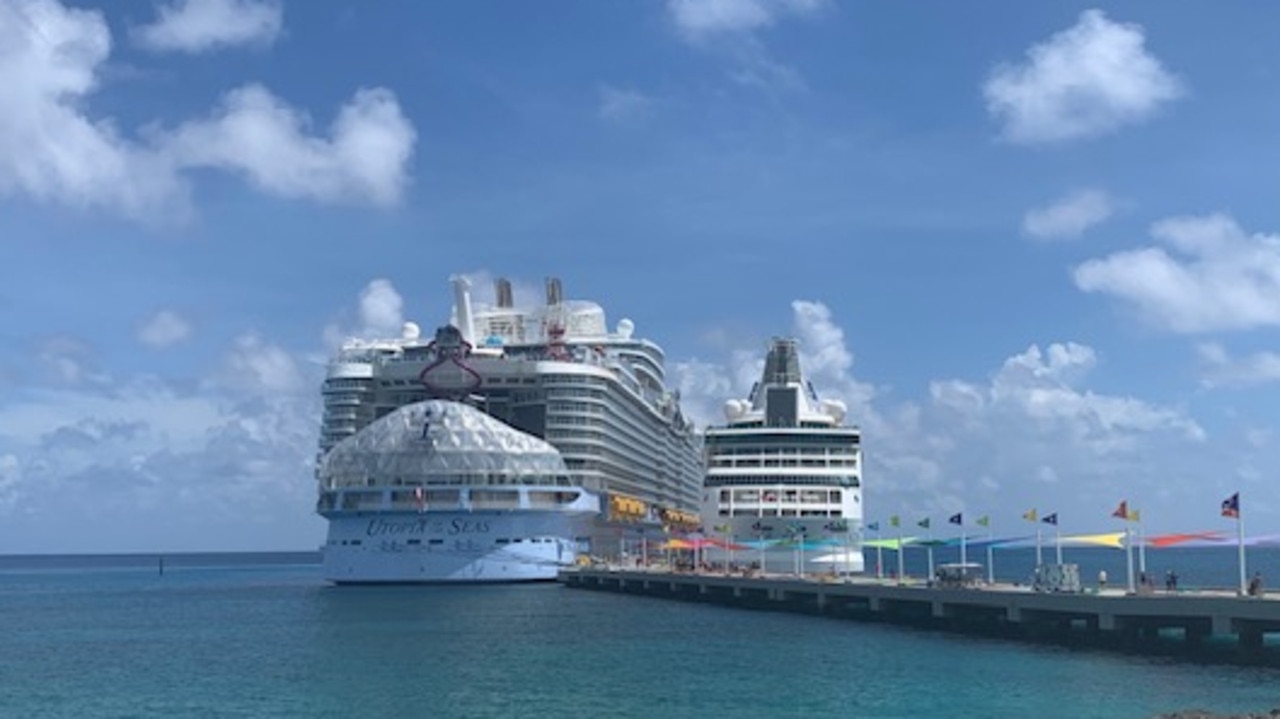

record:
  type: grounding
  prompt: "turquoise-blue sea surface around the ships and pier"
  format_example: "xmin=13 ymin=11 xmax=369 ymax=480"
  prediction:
xmin=0 ymin=549 xmax=1280 ymax=719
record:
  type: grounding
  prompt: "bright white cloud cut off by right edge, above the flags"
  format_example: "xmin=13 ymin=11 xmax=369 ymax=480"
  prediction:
xmin=1074 ymin=214 xmax=1280 ymax=333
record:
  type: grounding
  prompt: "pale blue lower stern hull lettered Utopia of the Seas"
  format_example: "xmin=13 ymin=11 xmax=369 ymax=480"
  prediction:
xmin=323 ymin=510 xmax=595 ymax=585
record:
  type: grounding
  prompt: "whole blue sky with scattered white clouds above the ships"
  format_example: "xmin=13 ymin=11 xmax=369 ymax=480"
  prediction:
xmin=0 ymin=0 xmax=1280 ymax=553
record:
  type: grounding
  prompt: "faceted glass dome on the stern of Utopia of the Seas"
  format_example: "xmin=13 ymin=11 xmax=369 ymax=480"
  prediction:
xmin=320 ymin=399 xmax=568 ymax=489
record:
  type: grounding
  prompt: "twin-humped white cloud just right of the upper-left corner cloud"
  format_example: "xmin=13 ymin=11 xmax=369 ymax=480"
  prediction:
xmin=163 ymin=84 xmax=416 ymax=205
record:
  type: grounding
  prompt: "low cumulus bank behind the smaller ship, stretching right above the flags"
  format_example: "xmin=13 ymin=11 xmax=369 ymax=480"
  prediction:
xmin=669 ymin=301 xmax=1211 ymax=526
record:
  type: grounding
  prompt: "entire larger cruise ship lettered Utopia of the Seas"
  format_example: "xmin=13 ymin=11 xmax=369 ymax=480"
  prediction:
xmin=316 ymin=276 xmax=701 ymax=583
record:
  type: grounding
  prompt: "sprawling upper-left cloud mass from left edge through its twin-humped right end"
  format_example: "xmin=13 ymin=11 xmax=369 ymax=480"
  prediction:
xmin=0 ymin=0 xmax=416 ymax=219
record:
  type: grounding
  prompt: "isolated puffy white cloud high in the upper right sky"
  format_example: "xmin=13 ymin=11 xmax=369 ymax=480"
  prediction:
xmin=983 ymin=10 xmax=1184 ymax=143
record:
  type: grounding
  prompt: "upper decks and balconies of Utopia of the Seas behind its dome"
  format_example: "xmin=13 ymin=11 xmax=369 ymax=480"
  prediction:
xmin=320 ymin=271 xmax=701 ymax=578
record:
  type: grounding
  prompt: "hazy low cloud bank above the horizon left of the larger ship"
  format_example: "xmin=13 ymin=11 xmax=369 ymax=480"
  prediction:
xmin=0 ymin=324 xmax=323 ymax=551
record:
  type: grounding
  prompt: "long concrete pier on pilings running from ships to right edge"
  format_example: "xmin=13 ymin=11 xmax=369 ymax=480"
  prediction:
xmin=558 ymin=567 xmax=1280 ymax=664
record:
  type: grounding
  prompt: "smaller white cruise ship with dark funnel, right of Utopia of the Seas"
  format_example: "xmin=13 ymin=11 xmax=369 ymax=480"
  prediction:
xmin=701 ymin=339 xmax=864 ymax=573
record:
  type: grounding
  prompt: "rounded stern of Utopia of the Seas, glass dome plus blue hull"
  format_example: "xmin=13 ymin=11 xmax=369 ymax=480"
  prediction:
xmin=317 ymin=399 xmax=602 ymax=585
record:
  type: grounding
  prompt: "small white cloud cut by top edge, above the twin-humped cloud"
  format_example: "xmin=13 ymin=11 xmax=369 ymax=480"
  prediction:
xmin=134 ymin=0 xmax=284 ymax=52
